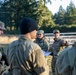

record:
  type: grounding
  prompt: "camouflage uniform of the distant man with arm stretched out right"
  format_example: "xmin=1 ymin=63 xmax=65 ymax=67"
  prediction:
xmin=51 ymin=38 xmax=67 ymax=75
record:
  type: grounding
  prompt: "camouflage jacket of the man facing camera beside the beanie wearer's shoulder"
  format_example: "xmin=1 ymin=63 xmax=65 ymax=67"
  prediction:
xmin=34 ymin=38 xmax=49 ymax=52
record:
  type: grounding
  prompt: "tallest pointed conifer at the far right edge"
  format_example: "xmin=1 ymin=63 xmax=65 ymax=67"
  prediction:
xmin=65 ymin=1 xmax=76 ymax=25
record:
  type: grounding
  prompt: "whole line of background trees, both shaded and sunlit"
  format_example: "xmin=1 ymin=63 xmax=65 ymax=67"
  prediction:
xmin=0 ymin=0 xmax=76 ymax=32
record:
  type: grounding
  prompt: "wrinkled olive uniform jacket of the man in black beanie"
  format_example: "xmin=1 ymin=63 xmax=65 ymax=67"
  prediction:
xmin=7 ymin=35 xmax=49 ymax=75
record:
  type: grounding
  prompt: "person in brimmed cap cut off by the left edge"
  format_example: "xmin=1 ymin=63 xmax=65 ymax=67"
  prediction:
xmin=0 ymin=21 xmax=9 ymax=75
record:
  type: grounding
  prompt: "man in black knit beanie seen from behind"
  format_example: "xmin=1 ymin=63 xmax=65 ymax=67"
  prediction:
xmin=7 ymin=17 xmax=49 ymax=75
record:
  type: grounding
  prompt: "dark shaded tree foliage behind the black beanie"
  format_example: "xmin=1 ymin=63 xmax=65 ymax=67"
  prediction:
xmin=1 ymin=0 xmax=37 ymax=30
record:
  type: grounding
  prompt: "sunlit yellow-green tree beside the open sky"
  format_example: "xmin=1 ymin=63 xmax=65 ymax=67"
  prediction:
xmin=37 ymin=1 xmax=55 ymax=28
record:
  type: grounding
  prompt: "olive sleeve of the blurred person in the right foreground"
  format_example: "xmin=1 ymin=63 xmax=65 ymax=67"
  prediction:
xmin=56 ymin=49 xmax=71 ymax=75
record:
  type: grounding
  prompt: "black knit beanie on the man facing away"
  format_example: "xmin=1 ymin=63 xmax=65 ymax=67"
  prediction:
xmin=20 ymin=17 xmax=38 ymax=34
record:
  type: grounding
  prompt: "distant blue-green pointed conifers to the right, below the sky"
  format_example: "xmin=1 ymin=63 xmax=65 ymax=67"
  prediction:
xmin=53 ymin=1 xmax=76 ymax=25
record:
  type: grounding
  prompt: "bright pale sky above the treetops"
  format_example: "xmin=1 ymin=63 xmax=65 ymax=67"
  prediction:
xmin=47 ymin=0 xmax=76 ymax=14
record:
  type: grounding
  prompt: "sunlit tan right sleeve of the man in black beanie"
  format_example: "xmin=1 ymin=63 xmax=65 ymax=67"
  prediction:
xmin=30 ymin=50 xmax=49 ymax=75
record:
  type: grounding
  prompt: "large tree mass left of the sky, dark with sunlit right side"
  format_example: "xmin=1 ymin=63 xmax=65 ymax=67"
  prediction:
xmin=0 ymin=0 xmax=54 ymax=30
